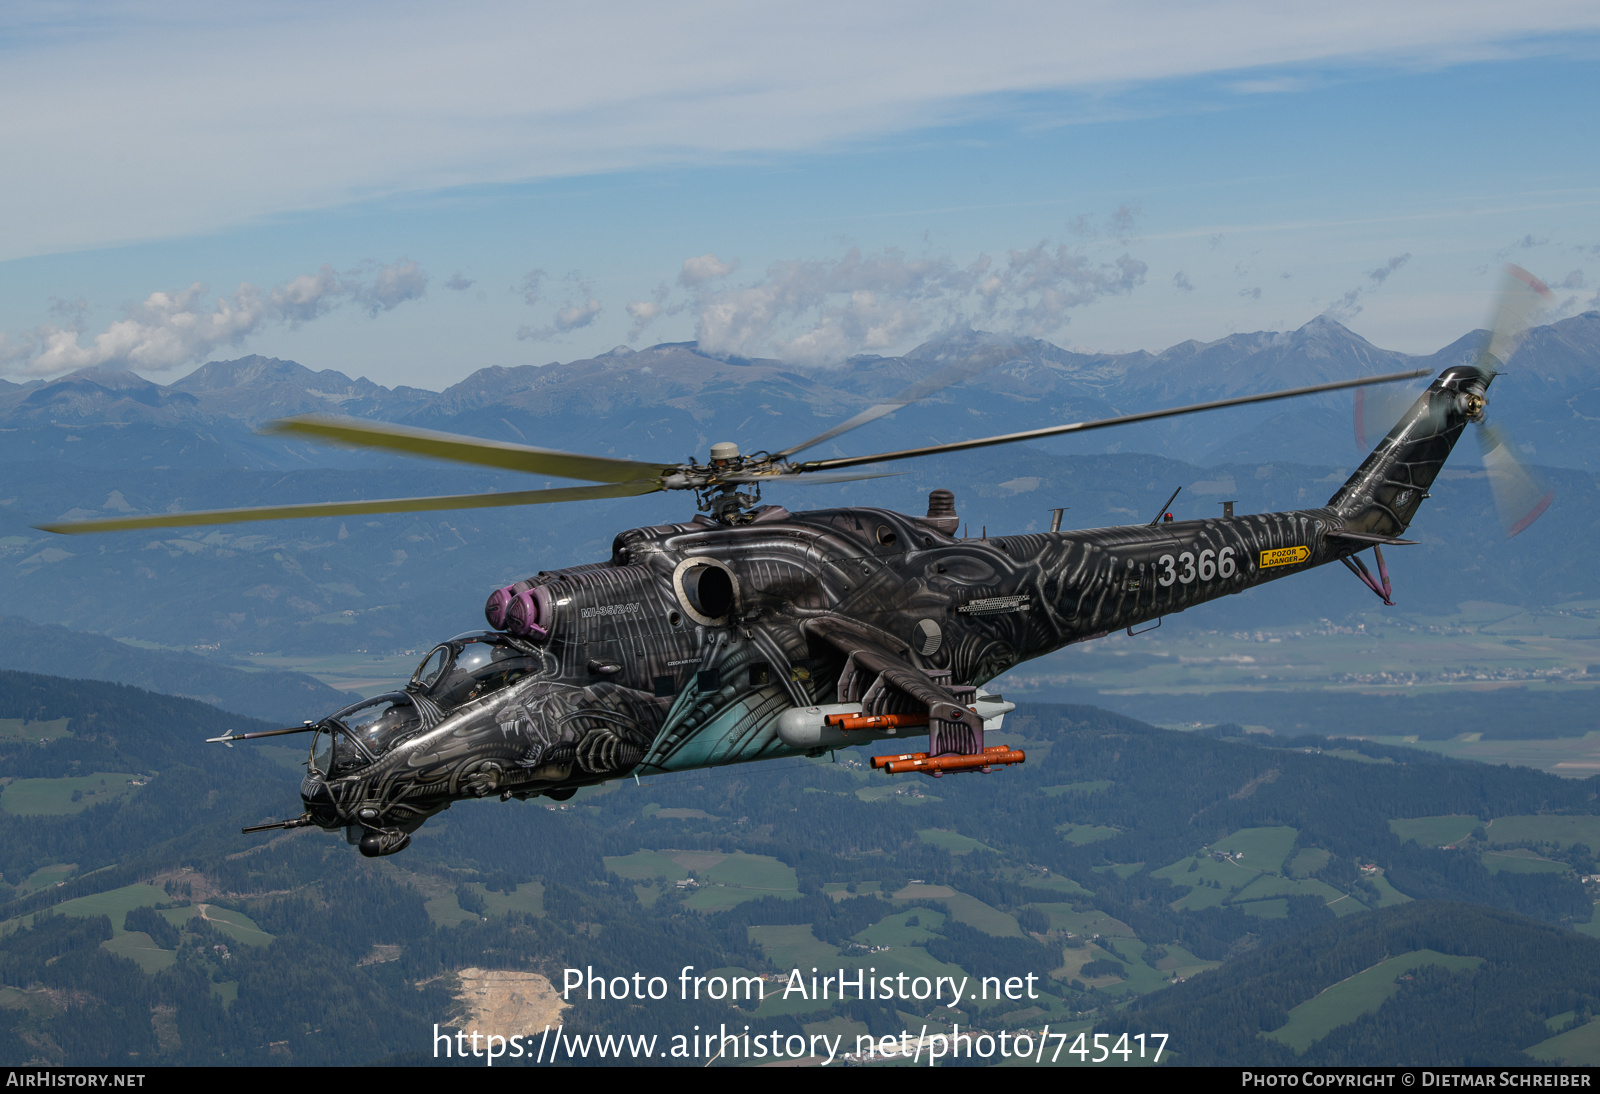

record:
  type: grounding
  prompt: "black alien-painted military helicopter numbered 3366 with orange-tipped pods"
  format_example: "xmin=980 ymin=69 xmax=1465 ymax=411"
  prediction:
xmin=42 ymin=267 xmax=1550 ymax=856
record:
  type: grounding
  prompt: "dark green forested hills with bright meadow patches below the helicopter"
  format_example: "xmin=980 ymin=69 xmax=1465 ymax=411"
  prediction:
xmin=0 ymin=673 xmax=1600 ymax=1064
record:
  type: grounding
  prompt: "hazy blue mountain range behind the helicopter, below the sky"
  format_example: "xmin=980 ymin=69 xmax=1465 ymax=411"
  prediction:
xmin=0 ymin=312 xmax=1600 ymax=662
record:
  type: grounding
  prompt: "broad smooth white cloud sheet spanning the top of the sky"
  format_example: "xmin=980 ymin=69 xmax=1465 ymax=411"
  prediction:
xmin=0 ymin=0 xmax=1600 ymax=261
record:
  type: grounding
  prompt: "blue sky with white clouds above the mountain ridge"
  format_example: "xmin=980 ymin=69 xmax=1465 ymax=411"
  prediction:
xmin=0 ymin=0 xmax=1600 ymax=389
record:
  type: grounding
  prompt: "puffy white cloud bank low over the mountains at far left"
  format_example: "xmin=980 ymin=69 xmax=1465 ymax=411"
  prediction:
xmin=0 ymin=259 xmax=427 ymax=376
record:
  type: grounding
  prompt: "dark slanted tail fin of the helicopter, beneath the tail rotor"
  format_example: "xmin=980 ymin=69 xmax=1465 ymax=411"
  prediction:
xmin=1328 ymin=365 xmax=1494 ymax=536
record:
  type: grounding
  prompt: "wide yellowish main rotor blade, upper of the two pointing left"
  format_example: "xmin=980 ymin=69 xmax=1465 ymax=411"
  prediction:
xmin=261 ymin=414 xmax=675 ymax=483
